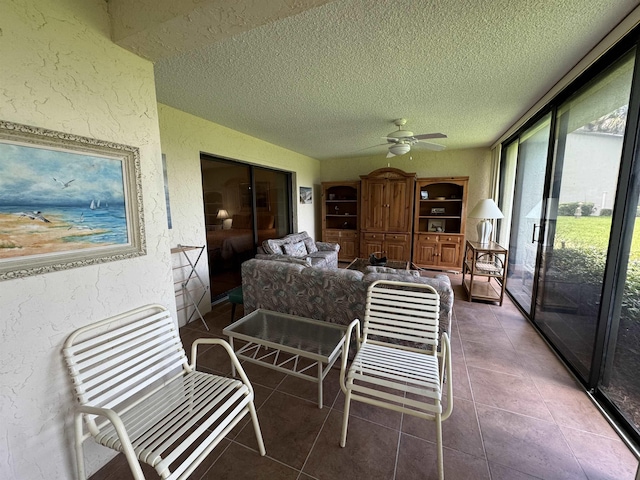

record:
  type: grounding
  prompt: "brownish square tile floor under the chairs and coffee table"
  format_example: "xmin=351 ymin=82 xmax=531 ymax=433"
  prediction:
xmin=91 ymin=275 xmax=638 ymax=480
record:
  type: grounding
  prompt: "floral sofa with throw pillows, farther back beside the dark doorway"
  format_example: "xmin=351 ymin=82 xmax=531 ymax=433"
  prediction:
xmin=256 ymin=232 xmax=340 ymax=268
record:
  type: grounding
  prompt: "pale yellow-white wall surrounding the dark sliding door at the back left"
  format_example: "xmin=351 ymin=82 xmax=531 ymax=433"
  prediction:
xmin=158 ymin=104 xmax=320 ymax=258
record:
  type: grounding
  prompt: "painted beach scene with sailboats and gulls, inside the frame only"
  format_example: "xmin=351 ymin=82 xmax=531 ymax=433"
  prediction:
xmin=0 ymin=143 xmax=129 ymax=261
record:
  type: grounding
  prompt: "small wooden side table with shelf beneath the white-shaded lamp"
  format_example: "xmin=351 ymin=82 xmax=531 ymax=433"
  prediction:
xmin=462 ymin=240 xmax=509 ymax=306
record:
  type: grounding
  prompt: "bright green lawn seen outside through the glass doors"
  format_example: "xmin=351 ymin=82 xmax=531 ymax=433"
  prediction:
xmin=554 ymin=217 xmax=640 ymax=260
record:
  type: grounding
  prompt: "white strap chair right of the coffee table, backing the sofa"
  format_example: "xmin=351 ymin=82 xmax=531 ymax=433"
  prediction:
xmin=340 ymin=280 xmax=453 ymax=479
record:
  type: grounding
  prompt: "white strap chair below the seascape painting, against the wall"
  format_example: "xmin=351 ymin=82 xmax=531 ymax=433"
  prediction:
xmin=63 ymin=305 xmax=265 ymax=479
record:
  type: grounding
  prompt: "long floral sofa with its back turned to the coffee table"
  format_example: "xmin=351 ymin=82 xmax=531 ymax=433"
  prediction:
xmin=242 ymin=258 xmax=453 ymax=338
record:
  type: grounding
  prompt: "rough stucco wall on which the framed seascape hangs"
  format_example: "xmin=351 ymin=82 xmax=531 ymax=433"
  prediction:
xmin=0 ymin=0 xmax=175 ymax=480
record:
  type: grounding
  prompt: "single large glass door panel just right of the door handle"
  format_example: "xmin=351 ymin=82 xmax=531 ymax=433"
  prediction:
xmin=534 ymin=54 xmax=634 ymax=381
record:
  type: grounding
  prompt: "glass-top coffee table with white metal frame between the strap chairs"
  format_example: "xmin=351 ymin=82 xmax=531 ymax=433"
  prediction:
xmin=222 ymin=309 xmax=347 ymax=408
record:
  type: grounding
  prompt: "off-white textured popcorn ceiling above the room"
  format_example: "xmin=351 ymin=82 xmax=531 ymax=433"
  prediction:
xmin=110 ymin=0 xmax=639 ymax=159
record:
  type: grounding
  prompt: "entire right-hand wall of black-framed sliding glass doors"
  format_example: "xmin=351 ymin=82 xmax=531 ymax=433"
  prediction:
xmin=498 ymin=47 xmax=640 ymax=440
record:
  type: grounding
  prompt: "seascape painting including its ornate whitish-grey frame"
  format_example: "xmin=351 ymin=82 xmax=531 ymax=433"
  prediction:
xmin=0 ymin=120 xmax=146 ymax=280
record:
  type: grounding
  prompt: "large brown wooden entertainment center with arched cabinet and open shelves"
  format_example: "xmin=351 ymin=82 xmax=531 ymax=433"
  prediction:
xmin=322 ymin=168 xmax=469 ymax=271
